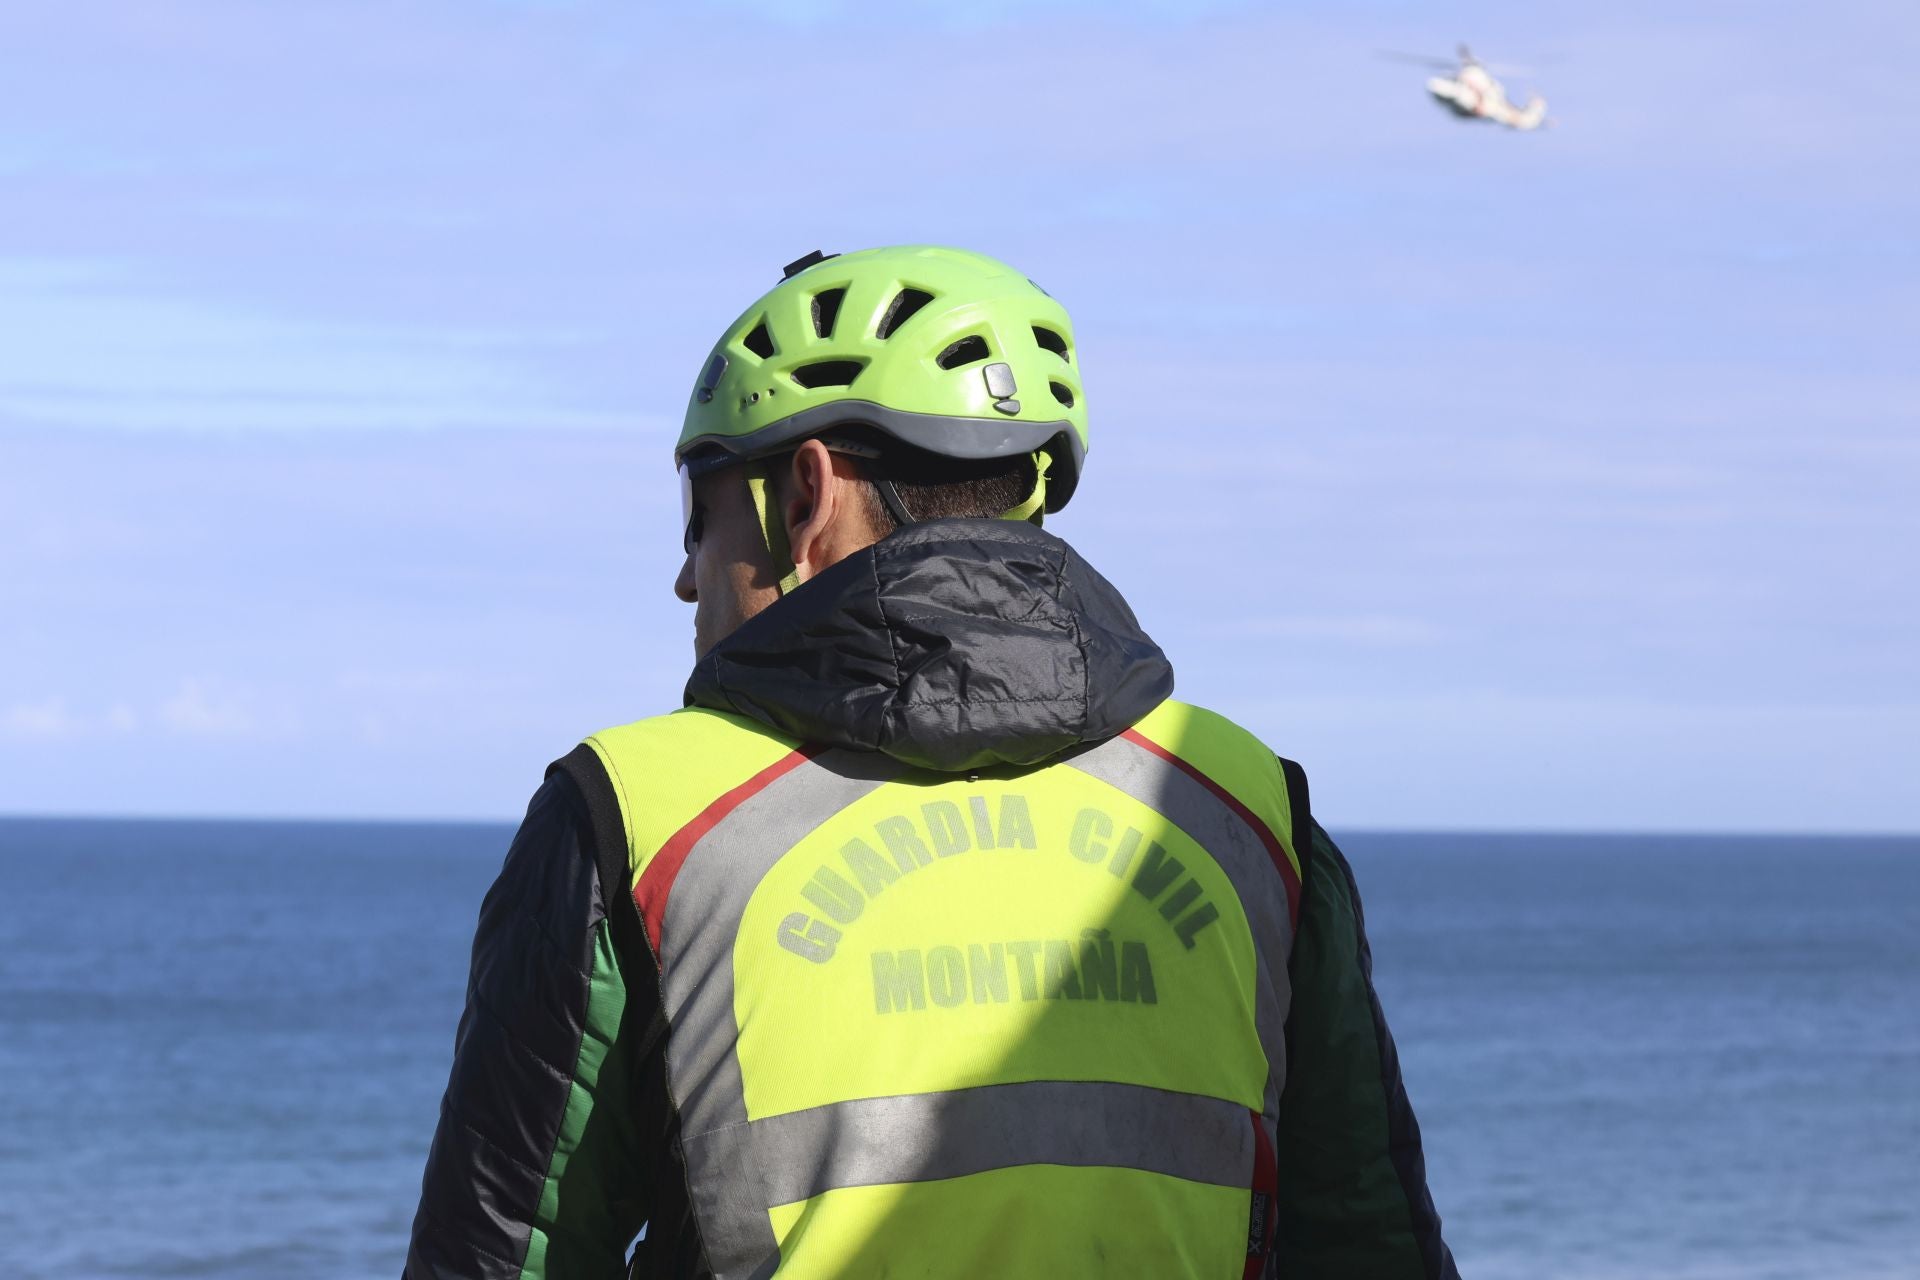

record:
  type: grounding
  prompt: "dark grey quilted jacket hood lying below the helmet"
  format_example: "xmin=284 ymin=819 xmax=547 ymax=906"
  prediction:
xmin=687 ymin=520 xmax=1173 ymax=771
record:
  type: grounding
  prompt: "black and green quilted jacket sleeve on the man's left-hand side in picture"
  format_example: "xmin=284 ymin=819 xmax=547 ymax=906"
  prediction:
xmin=405 ymin=770 xmax=649 ymax=1280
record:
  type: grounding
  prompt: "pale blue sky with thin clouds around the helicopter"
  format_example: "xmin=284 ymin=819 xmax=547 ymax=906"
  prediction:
xmin=0 ymin=0 xmax=1920 ymax=831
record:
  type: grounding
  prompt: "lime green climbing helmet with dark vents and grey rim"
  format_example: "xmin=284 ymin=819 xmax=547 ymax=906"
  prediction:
xmin=674 ymin=246 xmax=1087 ymax=510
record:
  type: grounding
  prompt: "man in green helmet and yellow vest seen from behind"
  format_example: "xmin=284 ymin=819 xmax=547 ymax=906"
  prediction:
xmin=407 ymin=248 xmax=1455 ymax=1280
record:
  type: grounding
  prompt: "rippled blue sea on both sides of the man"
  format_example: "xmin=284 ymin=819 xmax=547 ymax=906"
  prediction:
xmin=0 ymin=818 xmax=1920 ymax=1280
